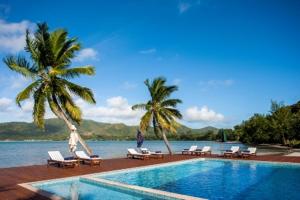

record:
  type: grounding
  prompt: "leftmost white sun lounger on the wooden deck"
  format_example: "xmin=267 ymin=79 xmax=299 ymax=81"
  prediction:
xmin=47 ymin=151 xmax=79 ymax=167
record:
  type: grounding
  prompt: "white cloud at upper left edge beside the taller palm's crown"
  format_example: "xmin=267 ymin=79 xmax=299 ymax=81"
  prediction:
xmin=0 ymin=19 xmax=33 ymax=53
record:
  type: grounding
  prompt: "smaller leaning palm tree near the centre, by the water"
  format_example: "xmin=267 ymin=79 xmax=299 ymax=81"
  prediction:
xmin=132 ymin=77 xmax=182 ymax=154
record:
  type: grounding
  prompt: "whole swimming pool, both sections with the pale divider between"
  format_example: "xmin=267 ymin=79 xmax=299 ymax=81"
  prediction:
xmin=22 ymin=159 xmax=300 ymax=200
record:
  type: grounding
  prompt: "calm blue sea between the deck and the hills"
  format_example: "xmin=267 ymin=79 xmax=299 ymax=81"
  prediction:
xmin=0 ymin=141 xmax=246 ymax=168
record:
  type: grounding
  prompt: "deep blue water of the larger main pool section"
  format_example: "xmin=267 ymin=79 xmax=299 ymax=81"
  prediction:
xmin=98 ymin=160 xmax=300 ymax=200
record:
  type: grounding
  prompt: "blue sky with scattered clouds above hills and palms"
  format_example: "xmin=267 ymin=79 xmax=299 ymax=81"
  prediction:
xmin=0 ymin=0 xmax=300 ymax=128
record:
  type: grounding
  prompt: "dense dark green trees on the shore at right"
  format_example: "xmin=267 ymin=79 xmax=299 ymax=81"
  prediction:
xmin=235 ymin=101 xmax=300 ymax=146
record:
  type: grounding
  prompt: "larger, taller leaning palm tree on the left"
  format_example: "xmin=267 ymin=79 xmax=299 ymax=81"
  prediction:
xmin=3 ymin=23 xmax=96 ymax=154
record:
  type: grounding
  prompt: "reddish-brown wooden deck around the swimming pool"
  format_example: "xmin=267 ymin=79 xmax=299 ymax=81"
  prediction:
xmin=0 ymin=155 xmax=300 ymax=200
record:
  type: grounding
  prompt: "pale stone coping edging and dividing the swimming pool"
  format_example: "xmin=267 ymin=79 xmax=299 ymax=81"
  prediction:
xmin=18 ymin=157 xmax=300 ymax=200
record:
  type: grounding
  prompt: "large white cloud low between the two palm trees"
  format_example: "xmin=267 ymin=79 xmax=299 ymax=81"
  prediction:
xmin=76 ymin=96 xmax=143 ymax=125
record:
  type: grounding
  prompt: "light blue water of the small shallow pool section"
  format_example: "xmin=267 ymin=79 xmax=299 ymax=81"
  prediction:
xmin=33 ymin=179 xmax=163 ymax=200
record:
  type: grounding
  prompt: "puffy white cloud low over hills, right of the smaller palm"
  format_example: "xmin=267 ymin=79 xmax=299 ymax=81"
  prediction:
xmin=185 ymin=106 xmax=225 ymax=122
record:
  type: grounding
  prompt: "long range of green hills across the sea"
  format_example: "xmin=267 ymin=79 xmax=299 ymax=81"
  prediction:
xmin=0 ymin=119 xmax=218 ymax=140
